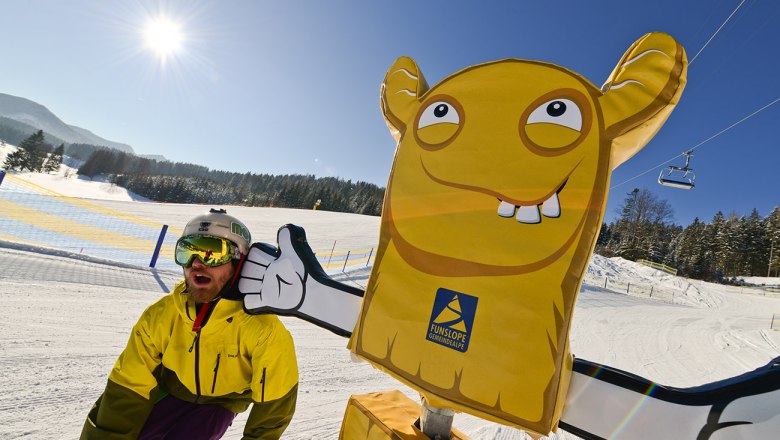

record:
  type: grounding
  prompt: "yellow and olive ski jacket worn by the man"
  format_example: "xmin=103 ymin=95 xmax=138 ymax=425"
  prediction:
xmin=81 ymin=281 xmax=298 ymax=440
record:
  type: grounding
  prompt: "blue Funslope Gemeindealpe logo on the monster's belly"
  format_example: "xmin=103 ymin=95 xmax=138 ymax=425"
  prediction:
xmin=425 ymin=287 xmax=477 ymax=352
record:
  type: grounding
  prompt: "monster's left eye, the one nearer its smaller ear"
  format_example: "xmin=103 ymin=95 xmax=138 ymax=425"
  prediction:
xmin=414 ymin=95 xmax=464 ymax=151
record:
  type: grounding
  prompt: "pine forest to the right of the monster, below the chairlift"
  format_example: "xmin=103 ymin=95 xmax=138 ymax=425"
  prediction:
xmin=596 ymin=189 xmax=780 ymax=282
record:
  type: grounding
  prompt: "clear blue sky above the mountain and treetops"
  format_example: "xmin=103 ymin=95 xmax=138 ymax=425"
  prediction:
xmin=0 ymin=0 xmax=780 ymax=225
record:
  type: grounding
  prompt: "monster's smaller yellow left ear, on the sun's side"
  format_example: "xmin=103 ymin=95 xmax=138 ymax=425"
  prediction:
xmin=381 ymin=57 xmax=428 ymax=142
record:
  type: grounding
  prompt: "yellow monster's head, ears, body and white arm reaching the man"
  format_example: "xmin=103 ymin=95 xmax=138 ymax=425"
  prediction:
xmin=240 ymin=33 xmax=687 ymax=434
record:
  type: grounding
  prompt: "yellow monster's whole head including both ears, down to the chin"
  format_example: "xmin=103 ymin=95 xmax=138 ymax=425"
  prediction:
xmin=382 ymin=34 xmax=685 ymax=276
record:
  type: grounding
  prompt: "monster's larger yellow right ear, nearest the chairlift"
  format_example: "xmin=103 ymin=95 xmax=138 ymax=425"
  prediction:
xmin=599 ymin=32 xmax=688 ymax=169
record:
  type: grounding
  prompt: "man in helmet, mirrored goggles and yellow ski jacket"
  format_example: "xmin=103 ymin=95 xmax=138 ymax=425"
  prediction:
xmin=81 ymin=209 xmax=298 ymax=440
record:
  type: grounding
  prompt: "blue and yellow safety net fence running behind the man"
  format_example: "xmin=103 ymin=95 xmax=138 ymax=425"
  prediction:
xmin=0 ymin=171 xmax=374 ymax=272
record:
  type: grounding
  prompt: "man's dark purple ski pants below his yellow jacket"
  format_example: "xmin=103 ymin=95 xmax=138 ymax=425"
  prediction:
xmin=138 ymin=395 xmax=236 ymax=440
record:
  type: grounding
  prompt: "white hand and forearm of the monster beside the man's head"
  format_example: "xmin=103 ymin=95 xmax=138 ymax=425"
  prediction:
xmin=238 ymin=224 xmax=363 ymax=336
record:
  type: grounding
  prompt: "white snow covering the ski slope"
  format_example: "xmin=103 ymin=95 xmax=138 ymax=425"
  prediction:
xmin=0 ymin=152 xmax=780 ymax=440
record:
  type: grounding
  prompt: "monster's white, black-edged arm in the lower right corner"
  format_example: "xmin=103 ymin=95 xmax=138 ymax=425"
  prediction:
xmin=560 ymin=358 xmax=780 ymax=439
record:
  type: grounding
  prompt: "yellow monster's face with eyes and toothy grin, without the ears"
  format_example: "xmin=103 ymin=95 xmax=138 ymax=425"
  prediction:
xmin=385 ymin=60 xmax=609 ymax=275
